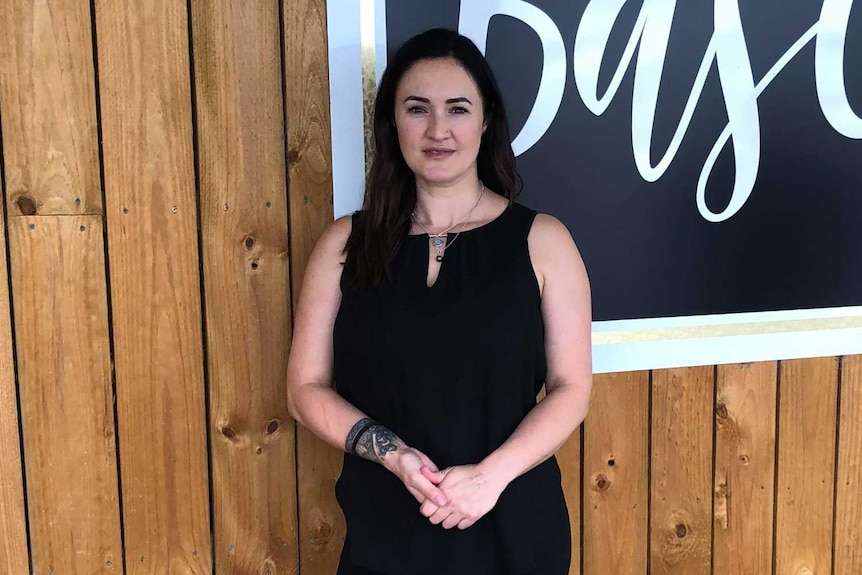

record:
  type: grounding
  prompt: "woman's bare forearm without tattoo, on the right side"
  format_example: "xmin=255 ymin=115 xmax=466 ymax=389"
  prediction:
xmin=479 ymin=385 xmax=590 ymax=483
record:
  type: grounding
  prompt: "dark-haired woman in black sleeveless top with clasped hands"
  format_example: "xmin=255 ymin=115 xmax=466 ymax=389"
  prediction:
xmin=288 ymin=29 xmax=591 ymax=575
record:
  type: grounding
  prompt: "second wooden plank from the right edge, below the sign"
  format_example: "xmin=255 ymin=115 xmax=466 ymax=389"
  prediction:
xmin=775 ymin=357 xmax=838 ymax=575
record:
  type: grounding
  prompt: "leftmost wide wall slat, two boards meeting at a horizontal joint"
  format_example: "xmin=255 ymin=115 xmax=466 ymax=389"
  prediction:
xmin=0 ymin=0 xmax=117 ymax=573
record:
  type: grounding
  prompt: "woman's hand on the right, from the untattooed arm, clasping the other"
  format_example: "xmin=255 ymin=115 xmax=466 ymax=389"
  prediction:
xmin=419 ymin=465 xmax=507 ymax=529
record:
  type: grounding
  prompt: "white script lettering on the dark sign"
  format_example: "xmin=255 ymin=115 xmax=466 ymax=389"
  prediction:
xmin=466 ymin=0 xmax=862 ymax=222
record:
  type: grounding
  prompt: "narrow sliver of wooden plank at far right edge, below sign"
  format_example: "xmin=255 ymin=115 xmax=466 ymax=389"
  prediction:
xmin=835 ymin=355 xmax=862 ymax=575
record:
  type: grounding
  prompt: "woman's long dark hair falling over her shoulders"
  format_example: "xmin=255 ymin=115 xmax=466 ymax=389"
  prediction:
xmin=345 ymin=28 xmax=521 ymax=289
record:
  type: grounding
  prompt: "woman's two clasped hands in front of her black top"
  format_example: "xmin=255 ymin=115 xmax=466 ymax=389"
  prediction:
xmin=387 ymin=447 xmax=508 ymax=529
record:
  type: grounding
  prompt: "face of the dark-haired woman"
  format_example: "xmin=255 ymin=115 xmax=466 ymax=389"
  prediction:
xmin=395 ymin=58 xmax=485 ymax=186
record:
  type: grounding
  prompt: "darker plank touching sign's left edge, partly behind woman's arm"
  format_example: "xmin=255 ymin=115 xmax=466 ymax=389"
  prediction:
xmin=284 ymin=0 xmax=345 ymax=575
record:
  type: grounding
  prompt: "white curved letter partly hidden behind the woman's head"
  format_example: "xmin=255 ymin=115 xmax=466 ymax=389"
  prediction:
xmin=458 ymin=0 xmax=566 ymax=156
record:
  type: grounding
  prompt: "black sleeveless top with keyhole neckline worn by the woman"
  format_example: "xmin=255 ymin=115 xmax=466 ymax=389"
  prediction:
xmin=333 ymin=204 xmax=571 ymax=575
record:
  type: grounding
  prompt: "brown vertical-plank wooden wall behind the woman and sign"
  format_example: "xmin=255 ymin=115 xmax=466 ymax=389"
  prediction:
xmin=0 ymin=0 xmax=862 ymax=575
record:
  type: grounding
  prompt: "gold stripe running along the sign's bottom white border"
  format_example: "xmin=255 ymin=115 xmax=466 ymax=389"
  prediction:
xmin=593 ymin=316 xmax=862 ymax=344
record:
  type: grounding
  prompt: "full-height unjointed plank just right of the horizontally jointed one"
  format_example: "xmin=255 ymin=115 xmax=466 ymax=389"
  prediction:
xmin=95 ymin=0 xmax=212 ymax=575
